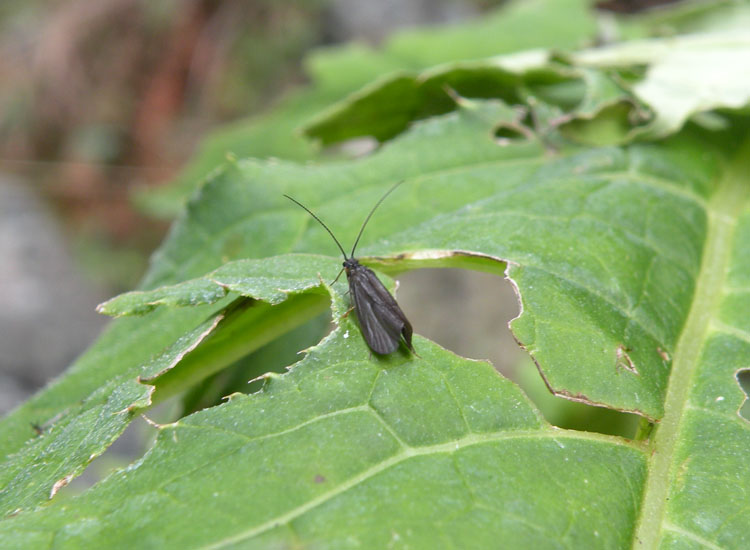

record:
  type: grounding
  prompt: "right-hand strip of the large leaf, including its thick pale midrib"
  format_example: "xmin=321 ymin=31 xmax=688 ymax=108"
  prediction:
xmin=636 ymin=138 xmax=750 ymax=548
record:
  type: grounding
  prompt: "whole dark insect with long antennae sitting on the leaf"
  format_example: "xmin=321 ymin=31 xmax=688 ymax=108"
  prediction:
xmin=284 ymin=182 xmax=414 ymax=355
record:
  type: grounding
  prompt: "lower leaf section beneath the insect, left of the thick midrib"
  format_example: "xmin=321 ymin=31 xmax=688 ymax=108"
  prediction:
xmin=0 ymin=334 xmax=645 ymax=548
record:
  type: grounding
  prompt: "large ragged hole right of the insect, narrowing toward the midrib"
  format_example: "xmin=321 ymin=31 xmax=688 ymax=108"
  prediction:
xmin=397 ymin=269 xmax=640 ymax=438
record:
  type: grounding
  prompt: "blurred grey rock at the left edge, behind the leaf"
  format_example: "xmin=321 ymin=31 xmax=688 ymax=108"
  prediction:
xmin=0 ymin=179 xmax=105 ymax=414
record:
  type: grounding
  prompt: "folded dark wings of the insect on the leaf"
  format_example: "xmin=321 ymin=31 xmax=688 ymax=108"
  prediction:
xmin=347 ymin=265 xmax=414 ymax=355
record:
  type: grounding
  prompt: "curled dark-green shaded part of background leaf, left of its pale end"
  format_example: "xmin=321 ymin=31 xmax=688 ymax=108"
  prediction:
xmin=304 ymin=51 xmax=647 ymax=145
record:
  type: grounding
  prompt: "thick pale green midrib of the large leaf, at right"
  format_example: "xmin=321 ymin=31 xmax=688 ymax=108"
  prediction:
xmin=633 ymin=139 xmax=750 ymax=549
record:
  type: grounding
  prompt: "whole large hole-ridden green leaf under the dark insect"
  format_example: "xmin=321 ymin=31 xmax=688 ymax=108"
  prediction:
xmin=0 ymin=0 xmax=750 ymax=548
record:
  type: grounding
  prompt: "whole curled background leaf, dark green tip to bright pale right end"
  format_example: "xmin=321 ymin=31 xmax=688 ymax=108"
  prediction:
xmin=305 ymin=31 xmax=750 ymax=145
